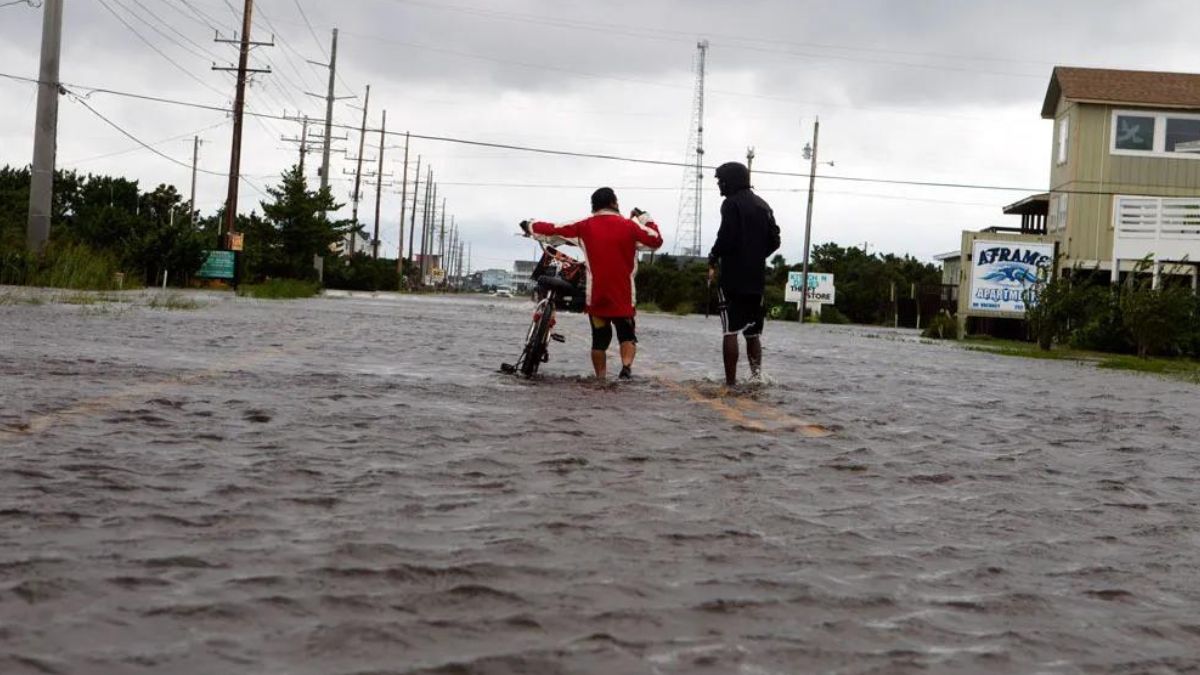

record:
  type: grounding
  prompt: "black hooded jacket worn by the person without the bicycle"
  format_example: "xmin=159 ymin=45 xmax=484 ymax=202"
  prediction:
xmin=708 ymin=163 xmax=779 ymax=295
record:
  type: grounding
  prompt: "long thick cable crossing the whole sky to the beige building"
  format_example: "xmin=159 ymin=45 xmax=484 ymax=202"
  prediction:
xmin=0 ymin=73 xmax=1180 ymax=197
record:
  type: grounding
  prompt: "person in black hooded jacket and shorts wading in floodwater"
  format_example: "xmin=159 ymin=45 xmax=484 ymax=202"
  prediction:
xmin=708 ymin=162 xmax=779 ymax=386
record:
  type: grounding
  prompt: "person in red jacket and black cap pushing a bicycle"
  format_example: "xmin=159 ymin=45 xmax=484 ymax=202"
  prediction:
xmin=521 ymin=187 xmax=662 ymax=380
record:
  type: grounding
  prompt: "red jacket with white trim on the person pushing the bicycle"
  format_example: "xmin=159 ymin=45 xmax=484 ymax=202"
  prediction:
xmin=530 ymin=209 xmax=662 ymax=318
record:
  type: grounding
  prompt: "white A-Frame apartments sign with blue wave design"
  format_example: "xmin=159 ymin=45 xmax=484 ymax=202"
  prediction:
xmin=971 ymin=239 xmax=1055 ymax=315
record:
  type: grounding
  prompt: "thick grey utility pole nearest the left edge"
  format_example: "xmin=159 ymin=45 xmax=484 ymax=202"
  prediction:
xmin=25 ymin=0 xmax=62 ymax=253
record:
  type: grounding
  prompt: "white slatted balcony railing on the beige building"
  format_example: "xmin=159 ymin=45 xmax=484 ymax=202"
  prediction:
xmin=1112 ymin=196 xmax=1200 ymax=263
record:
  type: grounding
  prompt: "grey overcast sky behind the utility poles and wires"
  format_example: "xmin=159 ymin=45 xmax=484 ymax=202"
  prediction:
xmin=0 ymin=0 xmax=1200 ymax=269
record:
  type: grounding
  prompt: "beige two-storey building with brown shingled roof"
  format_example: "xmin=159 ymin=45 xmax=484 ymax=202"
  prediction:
xmin=1042 ymin=67 xmax=1200 ymax=277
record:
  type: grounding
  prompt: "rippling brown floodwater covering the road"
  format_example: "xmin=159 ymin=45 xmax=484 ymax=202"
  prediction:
xmin=0 ymin=289 xmax=1200 ymax=675
